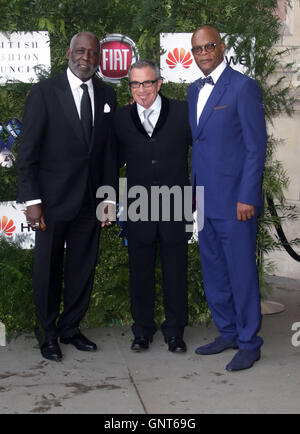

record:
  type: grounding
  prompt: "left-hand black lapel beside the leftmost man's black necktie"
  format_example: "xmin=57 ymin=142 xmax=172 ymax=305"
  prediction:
xmin=55 ymin=71 xmax=85 ymax=142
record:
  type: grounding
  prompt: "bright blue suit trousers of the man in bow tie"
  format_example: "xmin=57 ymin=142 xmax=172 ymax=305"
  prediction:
xmin=199 ymin=217 xmax=263 ymax=350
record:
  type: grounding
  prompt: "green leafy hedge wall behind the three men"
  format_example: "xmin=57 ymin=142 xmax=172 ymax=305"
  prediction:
xmin=0 ymin=0 xmax=295 ymax=330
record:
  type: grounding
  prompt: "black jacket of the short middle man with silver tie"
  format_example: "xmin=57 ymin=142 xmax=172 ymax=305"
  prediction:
xmin=114 ymin=96 xmax=192 ymax=243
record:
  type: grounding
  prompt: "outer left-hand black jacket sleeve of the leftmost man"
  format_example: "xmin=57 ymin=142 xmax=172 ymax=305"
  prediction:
xmin=17 ymin=85 xmax=47 ymax=202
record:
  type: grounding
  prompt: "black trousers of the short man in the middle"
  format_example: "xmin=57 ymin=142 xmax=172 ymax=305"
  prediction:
xmin=128 ymin=230 xmax=188 ymax=338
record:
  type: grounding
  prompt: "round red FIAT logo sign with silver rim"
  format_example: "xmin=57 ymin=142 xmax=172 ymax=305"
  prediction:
xmin=97 ymin=33 xmax=139 ymax=83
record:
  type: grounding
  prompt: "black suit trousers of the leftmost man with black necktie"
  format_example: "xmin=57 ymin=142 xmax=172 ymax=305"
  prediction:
xmin=33 ymin=195 xmax=100 ymax=339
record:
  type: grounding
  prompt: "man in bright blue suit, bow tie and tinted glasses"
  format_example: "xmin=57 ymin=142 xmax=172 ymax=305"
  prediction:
xmin=188 ymin=26 xmax=267 ymax=371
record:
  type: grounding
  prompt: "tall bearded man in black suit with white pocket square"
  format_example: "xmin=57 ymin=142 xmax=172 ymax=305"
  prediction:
xmin=18 ymin=32 xmax=117 ymax=361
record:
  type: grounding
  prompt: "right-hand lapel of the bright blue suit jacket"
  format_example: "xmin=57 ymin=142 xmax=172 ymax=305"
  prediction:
xmin=194 ymin=66 xmax=231 ymax=137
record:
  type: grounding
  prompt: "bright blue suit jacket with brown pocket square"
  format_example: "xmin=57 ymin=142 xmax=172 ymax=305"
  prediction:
xmin=188 ymin=66 xmax=267 ymax=219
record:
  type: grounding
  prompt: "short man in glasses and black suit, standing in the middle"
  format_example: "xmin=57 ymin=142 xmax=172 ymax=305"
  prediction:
xmin=114 ymin=61 xmax=191 ymax=352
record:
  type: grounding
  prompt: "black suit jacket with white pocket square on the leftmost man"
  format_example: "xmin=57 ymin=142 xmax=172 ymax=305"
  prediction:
xmin=17 ymin=71 xmax=117 ymax=220
